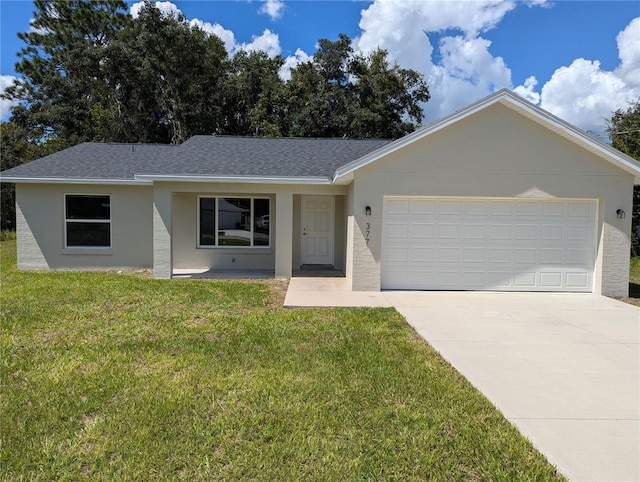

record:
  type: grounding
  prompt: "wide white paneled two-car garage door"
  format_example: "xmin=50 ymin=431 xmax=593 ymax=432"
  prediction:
xmin=381 ymin=197 xmax=596 ymax=292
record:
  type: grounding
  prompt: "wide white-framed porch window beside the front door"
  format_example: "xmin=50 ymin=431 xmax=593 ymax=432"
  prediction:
xmin=198 ymin=196 xmax=271 ymax=247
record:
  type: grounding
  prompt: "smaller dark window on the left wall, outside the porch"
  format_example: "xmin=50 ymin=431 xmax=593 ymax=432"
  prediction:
xmin=64 ymin=194 xmax=111 ymax=248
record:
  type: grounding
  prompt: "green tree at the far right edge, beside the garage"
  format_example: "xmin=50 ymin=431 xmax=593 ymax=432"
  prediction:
xmin=607 ymin=97 xmax=640 ymax=256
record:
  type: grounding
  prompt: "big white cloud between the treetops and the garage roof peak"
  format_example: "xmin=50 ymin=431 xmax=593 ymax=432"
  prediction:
xmin=354 ymin=0 xmax=516 ymax=121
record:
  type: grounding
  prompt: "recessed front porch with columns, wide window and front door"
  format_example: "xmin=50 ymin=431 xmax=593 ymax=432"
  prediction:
xmin=153 ymin=183 xmax=347 ymax=279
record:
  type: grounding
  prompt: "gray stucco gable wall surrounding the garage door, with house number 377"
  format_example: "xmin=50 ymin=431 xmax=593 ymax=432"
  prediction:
xmin=347 ymin=105 xmax=633 ymax=295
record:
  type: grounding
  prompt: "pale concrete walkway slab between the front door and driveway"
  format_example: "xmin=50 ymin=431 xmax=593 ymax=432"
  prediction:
xmin=284 ymin=277 xmax=391 ymax=308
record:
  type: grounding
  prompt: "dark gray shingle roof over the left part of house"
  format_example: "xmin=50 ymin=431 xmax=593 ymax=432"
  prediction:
xmin=2 ymin=136 xmax=391 ymax=180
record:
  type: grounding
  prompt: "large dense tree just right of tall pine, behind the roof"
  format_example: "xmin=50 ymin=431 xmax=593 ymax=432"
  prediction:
xmin=101 ymin=0 xmax=228 ymax=144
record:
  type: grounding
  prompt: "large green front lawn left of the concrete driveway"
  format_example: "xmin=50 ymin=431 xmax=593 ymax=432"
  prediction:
xmin=0 ymin=240 xmax=562 ymax=481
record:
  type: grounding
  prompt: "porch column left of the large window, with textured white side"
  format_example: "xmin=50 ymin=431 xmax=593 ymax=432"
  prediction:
xmin=153 ymin=184 xmax=173 ymax=279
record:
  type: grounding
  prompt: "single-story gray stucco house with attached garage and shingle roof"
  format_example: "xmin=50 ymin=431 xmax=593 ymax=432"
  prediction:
xmin=1 ymin=90 xmax=640 ymax=295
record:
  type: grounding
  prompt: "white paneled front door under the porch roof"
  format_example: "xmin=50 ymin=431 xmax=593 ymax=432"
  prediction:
xmin=302 ymin=196 xmax=335 ymax=265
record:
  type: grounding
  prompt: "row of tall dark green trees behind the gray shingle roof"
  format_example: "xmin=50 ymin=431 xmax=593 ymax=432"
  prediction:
xmin=4 ymin=0 xmax=429 ymax=148
